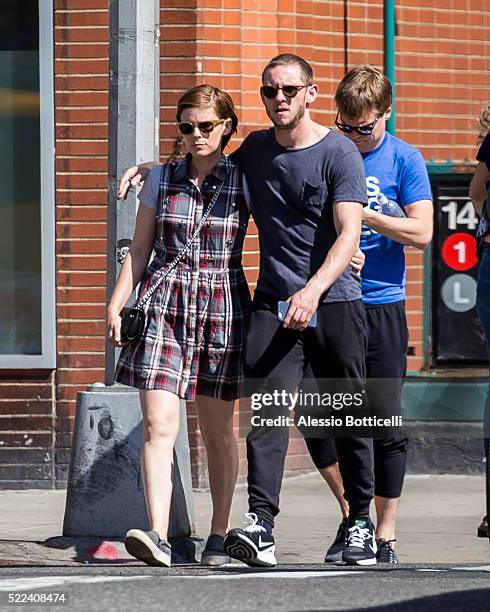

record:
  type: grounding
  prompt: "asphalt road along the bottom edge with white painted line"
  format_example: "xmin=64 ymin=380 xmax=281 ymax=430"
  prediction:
xmin=0 ymin=565 xmax=490 ymax=612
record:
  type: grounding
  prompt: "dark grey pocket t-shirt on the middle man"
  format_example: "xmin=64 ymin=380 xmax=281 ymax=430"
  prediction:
xmin=231 ymin=128 xmax=367 ymax=302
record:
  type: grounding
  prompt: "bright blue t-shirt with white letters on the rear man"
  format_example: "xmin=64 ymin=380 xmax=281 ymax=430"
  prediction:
xmin=361 ymin=132 xmax=432 ymax=304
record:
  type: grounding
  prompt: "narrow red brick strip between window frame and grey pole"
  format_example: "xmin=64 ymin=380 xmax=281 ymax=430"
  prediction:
xmin=54 ymin=0 xmax=109 ymax=483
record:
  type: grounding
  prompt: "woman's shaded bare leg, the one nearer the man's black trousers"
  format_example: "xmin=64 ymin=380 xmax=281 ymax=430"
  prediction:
xmin=196 ymin=395 xmax=238 ymax=535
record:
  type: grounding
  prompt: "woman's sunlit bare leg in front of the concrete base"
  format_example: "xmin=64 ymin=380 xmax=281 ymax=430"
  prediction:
xmin=140 ymin=390 xmax=180 ymax=540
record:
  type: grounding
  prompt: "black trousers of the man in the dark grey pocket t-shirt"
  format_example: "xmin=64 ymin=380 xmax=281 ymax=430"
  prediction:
xmin=245 ymin=292 xmax=374 ymax=525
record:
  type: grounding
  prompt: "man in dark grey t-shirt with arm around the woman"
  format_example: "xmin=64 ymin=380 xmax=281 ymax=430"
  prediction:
xmin=224 ymin=54 xmax=376 ymax=567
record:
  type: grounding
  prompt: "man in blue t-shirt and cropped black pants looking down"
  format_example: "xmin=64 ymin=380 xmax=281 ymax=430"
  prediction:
xmin=307 ymin=65 xmax=432 ymax=563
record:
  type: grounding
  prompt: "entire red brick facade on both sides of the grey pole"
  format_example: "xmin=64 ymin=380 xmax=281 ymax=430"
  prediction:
xmin=0 ymin=0 xmax=490 ymax=488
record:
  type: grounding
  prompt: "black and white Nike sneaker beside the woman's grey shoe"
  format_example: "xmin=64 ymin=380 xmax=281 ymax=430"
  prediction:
xmin=223 ymin=512 xmax=277 ymax=567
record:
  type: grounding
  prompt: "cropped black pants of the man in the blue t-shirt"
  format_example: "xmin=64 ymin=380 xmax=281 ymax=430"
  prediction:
xmin=306 ymin=301 xmax=408 ymax=498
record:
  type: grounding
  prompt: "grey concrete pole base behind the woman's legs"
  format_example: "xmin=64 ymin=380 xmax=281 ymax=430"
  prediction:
xmin=63 ymin=384 xmax=194 ymax=540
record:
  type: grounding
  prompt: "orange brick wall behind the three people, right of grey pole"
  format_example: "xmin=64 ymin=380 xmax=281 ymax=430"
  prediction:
xmin=161 ymin=0 xmax=490 ymax=486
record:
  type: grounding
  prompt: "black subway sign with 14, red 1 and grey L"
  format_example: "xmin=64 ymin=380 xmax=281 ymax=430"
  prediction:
xmin=431 ymin=175 xmax=487 ymax=367
